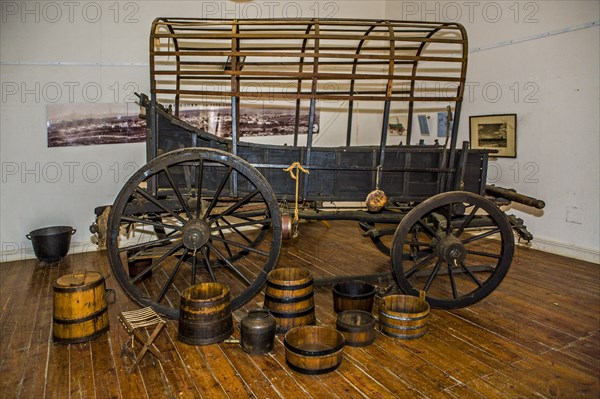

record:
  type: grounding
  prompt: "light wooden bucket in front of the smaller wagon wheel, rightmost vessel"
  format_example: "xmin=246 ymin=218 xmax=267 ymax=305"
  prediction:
xmin=379 ymin=291 xmax=429 ymax=339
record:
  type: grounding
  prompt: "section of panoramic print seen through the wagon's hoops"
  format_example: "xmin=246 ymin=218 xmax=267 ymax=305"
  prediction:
xmin=179 ymin=105 xmax=319 ymax=137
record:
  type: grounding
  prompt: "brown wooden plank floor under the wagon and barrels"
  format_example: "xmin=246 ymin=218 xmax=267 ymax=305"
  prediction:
xmin=0 ymin=222 xmax=600 ymax=399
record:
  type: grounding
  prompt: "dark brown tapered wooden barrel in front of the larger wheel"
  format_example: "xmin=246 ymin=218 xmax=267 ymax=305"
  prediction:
xmin=177 ymin=283 xmax=233 ymax=345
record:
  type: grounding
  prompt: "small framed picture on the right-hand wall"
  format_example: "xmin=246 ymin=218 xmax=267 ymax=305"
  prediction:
xmin=469 ymin=114 xmax=517 ymax=158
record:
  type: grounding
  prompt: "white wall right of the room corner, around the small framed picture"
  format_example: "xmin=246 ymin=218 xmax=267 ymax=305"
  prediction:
xmin=386 ymin=0 xmax=600 ymax=262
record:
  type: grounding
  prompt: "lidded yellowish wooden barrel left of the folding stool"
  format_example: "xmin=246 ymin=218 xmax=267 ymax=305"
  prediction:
xmin=52 ymin=271 xmax=109 ymax=344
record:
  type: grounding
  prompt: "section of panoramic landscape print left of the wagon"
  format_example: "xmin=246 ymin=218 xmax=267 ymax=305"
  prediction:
xmin=46 ymin=103 xmax=146 ymax=147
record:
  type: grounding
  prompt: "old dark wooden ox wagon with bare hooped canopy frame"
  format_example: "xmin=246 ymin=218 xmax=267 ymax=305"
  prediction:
xmin=101 ymin=18 xmax=543 ymax=317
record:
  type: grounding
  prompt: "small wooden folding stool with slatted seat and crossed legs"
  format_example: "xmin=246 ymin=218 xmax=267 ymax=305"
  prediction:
xmin=119 ymin=307 xmax=167 ymax=373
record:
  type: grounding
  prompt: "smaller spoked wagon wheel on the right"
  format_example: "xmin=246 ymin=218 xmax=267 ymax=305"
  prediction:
xmin=391 ymin=191 xmax=514 ymax=309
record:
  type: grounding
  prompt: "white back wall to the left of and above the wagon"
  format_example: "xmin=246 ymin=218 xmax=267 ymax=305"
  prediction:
xmin=0 ymin=0 xmax=385 ymax=261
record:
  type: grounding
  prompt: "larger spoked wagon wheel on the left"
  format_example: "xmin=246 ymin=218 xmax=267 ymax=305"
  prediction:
xmin=107 ymin=148 xmax=281 ymax=318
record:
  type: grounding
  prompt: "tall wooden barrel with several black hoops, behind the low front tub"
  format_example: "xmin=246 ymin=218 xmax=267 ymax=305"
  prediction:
xmin=264 ymin=267 xmax=316 ymax=333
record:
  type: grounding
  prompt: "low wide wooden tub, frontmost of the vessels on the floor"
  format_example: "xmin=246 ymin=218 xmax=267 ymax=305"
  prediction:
xmin=284 ymin=326 xmax=346 ymax=374
